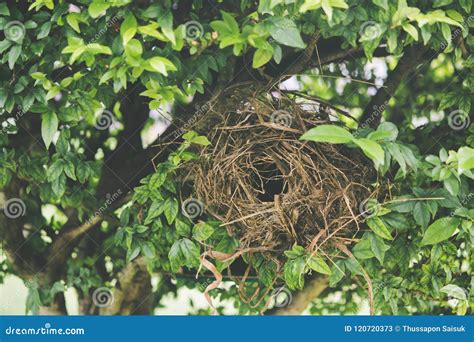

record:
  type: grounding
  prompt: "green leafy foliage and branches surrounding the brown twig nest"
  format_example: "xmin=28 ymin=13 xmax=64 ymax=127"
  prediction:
xmin=0 ymin=0 xmax=474 ymax=314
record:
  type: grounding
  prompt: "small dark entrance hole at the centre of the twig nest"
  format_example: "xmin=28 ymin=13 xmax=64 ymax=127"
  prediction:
xmin=251 ymin=163 xmax=288 ymax=202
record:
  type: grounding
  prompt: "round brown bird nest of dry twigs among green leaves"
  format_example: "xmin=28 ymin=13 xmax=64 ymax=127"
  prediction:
xmin=186 ymin=88 xmax=374 ymax=257
